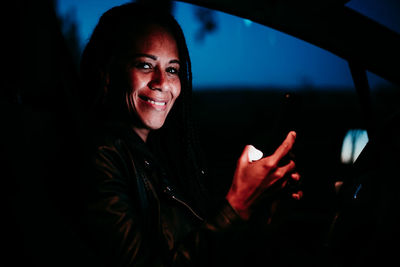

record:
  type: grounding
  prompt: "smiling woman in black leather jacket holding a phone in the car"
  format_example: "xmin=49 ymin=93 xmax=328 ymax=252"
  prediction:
xmin=81 ymin=3 xmax=299 ymax=266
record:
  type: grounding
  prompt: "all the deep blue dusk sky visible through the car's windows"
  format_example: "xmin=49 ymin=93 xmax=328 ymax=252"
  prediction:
xmin=57 ymin=0 xmax=400 ymax=90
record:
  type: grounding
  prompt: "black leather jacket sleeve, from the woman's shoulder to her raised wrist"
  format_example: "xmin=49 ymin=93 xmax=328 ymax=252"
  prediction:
xmin=87 ymin=144 xmax=241 ymax=266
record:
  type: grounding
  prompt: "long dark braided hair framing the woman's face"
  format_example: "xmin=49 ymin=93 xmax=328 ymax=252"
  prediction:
xmin=80 ymin=3 xmax=208 ymax=216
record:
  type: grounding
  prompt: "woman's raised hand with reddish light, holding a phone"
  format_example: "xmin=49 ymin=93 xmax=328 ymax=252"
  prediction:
xmin=226 ymin=131 xmax=300 ymax=220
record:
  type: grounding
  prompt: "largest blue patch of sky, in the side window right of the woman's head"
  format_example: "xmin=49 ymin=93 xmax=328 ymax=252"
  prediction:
xmin=174 ymin=3 xmax=353 ymax=89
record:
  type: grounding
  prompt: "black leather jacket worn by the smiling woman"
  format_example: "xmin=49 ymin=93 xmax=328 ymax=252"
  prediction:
xmin=83 ymin=124 xmax=240 ymax=266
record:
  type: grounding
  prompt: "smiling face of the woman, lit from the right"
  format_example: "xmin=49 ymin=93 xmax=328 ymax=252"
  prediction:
xmin=127 ymin=25 xmax=181 ymax=139
